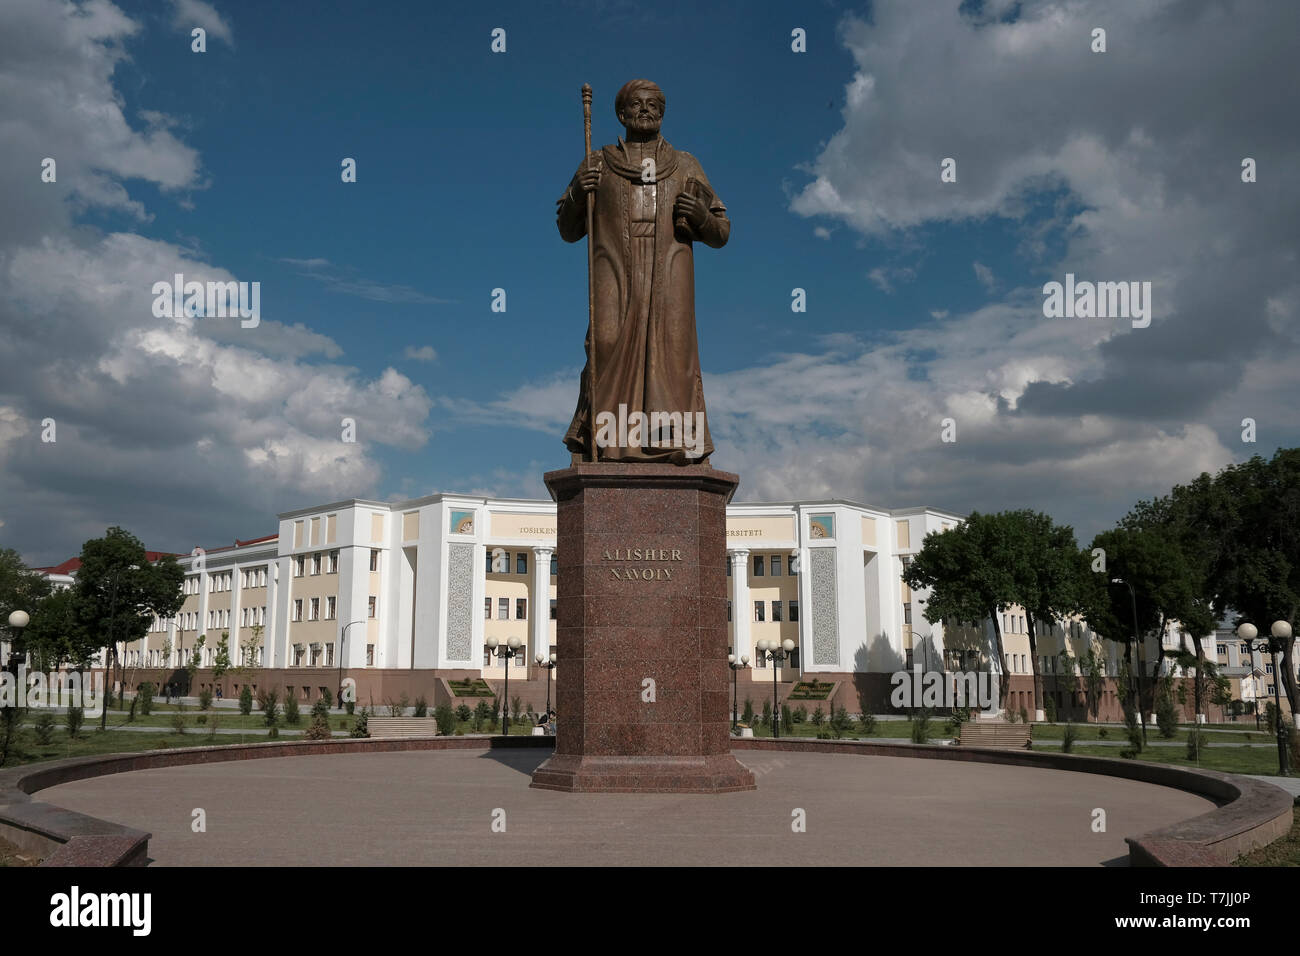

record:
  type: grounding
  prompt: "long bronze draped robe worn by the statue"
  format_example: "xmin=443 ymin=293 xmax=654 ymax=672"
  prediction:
xmin=556 ymin=137 xmax=731 ymax=464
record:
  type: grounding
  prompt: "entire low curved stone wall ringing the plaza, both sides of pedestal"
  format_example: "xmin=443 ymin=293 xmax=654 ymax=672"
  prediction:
xmin=0 ymin=736 xmax=1294 ymax=866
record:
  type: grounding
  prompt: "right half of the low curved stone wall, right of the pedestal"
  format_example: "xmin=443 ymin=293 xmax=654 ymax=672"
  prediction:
xmin=732 ymin=739 xmax=1295 ymax=866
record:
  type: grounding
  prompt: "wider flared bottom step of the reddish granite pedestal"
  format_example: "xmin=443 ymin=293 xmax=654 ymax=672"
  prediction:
xmin=530 ymin=753 xmax=758 ymax=793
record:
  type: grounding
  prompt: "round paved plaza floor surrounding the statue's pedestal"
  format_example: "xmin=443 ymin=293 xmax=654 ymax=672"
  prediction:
xmin=43 ymin=750 xmax=1214 ymax=866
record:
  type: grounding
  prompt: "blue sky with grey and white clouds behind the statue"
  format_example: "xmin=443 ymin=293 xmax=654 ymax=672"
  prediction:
xmin=0 ymin=0 xmax=1300 ymax=563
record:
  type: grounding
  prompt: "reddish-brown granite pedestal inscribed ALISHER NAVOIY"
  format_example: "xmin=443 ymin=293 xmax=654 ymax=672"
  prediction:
xmin=532 ymin=463 xmax=754 ymax=793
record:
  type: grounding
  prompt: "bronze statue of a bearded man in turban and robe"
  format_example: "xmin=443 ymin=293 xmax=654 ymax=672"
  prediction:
xmin=555 ymin=79 xmax=731 ymax=464
